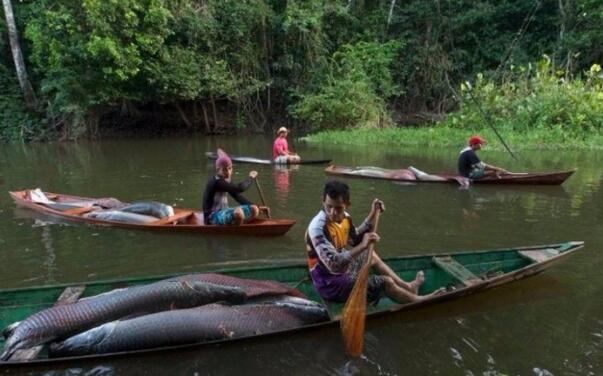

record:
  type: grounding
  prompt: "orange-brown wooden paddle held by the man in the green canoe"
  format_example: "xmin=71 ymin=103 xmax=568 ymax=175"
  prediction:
xmin=341 ymin=210 xmax=381 ymax=358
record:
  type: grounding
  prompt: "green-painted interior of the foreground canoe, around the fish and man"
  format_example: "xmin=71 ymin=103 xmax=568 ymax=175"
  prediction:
xmin=0 ymin=242 xmax=583 ymax=366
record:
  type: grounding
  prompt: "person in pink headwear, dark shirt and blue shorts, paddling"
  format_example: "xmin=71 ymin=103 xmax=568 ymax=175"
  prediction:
xmin=203 ymin=149 xmax=259 ymax=225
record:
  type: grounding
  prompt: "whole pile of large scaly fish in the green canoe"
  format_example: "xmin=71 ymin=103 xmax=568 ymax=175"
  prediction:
xmin=0 ymin=274 xmax=329 ymax=360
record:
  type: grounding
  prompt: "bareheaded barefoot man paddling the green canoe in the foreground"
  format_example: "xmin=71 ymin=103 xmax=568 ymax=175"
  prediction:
xmin=306 ymin=180 xmax=442 ymax=303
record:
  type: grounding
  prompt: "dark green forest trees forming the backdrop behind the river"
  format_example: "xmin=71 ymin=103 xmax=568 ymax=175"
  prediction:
xmin=0 ymin=0 xmax=603 ymax=139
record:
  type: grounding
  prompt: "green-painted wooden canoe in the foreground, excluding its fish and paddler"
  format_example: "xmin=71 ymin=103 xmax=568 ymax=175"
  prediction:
xmin=0 ymin=241 xmax=584 ymax=370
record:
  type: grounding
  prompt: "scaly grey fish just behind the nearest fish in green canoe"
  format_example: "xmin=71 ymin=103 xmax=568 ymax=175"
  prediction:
xmin=0 ymin=280 xmax=247 ymax=360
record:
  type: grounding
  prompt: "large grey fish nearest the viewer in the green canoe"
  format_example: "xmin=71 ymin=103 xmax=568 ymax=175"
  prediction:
xmin=50 ymin=297 xmax=329 ymax=357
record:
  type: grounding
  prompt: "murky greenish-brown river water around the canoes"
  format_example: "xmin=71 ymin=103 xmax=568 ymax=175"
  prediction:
xmin=0 ymin=136 xmax=603 ymax=375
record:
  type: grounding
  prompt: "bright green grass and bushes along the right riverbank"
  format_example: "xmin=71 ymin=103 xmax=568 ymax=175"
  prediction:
xmin=305 ymin=57 xmax=603 ymax=149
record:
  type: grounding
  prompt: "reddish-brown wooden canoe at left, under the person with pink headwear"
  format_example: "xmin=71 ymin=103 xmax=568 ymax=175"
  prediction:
xmin=9 ymin=190 xmax=295 ymax=236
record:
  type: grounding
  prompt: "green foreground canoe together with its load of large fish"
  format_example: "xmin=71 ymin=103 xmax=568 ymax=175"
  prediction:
xmin=0 ymin=241 xmax=584 ymax=370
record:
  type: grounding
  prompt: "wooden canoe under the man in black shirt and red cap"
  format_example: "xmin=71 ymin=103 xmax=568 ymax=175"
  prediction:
xmin=325 ymin=165 xmax=576 ymax=185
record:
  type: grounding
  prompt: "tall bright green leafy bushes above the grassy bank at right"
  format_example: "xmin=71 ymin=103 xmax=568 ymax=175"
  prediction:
xmin=443 ymin=59 xmax=603 ymax=142
